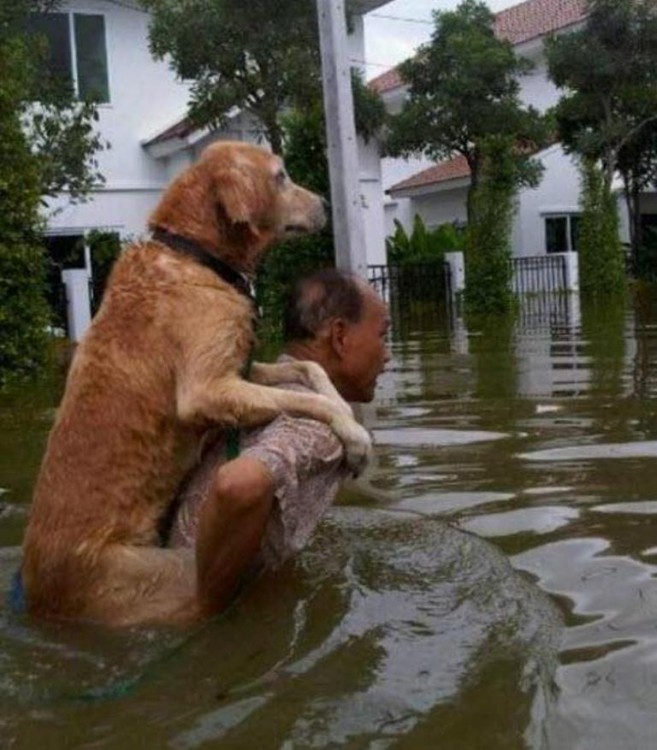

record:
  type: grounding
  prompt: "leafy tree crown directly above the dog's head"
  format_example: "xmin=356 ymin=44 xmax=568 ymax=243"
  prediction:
xmin=144 ymin=0 xmax=321 ymax=153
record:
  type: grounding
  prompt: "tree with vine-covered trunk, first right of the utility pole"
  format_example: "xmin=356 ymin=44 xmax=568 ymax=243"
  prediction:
xmin=386 ymin=0 xmax=547 ymax=313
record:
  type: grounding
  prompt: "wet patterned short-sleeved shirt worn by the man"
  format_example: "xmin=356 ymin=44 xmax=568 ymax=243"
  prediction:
xmin=170 ymin=356 xmax=349 ymax=568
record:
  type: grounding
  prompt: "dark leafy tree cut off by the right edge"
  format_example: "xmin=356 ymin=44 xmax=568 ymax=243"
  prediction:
xmin=547 ymin=0 xmax=657 ymax=274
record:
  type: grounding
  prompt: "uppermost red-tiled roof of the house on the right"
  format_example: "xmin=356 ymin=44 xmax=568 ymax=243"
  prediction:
xmin=368 ymin=0 xmax=586 ymax=94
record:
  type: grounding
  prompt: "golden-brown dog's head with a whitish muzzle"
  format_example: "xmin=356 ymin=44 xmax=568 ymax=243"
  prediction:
xmin=149 ymin=141 xmax=326 ymax=270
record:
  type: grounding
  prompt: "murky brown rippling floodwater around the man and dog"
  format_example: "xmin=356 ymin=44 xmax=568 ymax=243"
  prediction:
xmin=0 ymin=290 xmax=657 ymax=750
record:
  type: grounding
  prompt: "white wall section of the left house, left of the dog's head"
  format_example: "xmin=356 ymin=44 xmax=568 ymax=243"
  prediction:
xmin=48 ymin=0 xmax=189 ymax=235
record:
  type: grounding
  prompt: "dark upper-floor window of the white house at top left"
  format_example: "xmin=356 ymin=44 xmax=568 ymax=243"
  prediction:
xmin=30 ymin=13 xmax=109 ymax=103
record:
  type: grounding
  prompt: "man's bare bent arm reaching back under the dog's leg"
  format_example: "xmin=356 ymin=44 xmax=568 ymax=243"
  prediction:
xmin=196 ymin=456 xmax=275 ymax=615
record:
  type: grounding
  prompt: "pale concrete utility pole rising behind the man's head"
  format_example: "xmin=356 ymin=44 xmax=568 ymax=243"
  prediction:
xmin=317 ymin=0 xmax=367 ymax=278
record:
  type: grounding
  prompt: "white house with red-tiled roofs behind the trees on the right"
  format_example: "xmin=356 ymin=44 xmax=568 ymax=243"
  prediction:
xmin=369 ymin=0 xmax=657 ymax=257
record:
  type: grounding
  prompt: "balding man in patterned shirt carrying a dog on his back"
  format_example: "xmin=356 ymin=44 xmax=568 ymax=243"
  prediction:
xmin=170 ymin=269 xmax=389 ymax=606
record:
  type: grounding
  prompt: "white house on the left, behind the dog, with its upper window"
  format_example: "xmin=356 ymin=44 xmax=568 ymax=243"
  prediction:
xmin=39 ymin=0 xmax=387 ymax=274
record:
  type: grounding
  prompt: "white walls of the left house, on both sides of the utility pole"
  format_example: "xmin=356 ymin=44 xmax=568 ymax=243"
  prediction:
xmin=47 ymin=0 xmax=390 ymax=263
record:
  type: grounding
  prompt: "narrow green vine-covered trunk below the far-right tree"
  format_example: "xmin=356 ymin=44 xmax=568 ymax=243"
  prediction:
xmin=579 ymin=159 xmax=625 ymax=296
